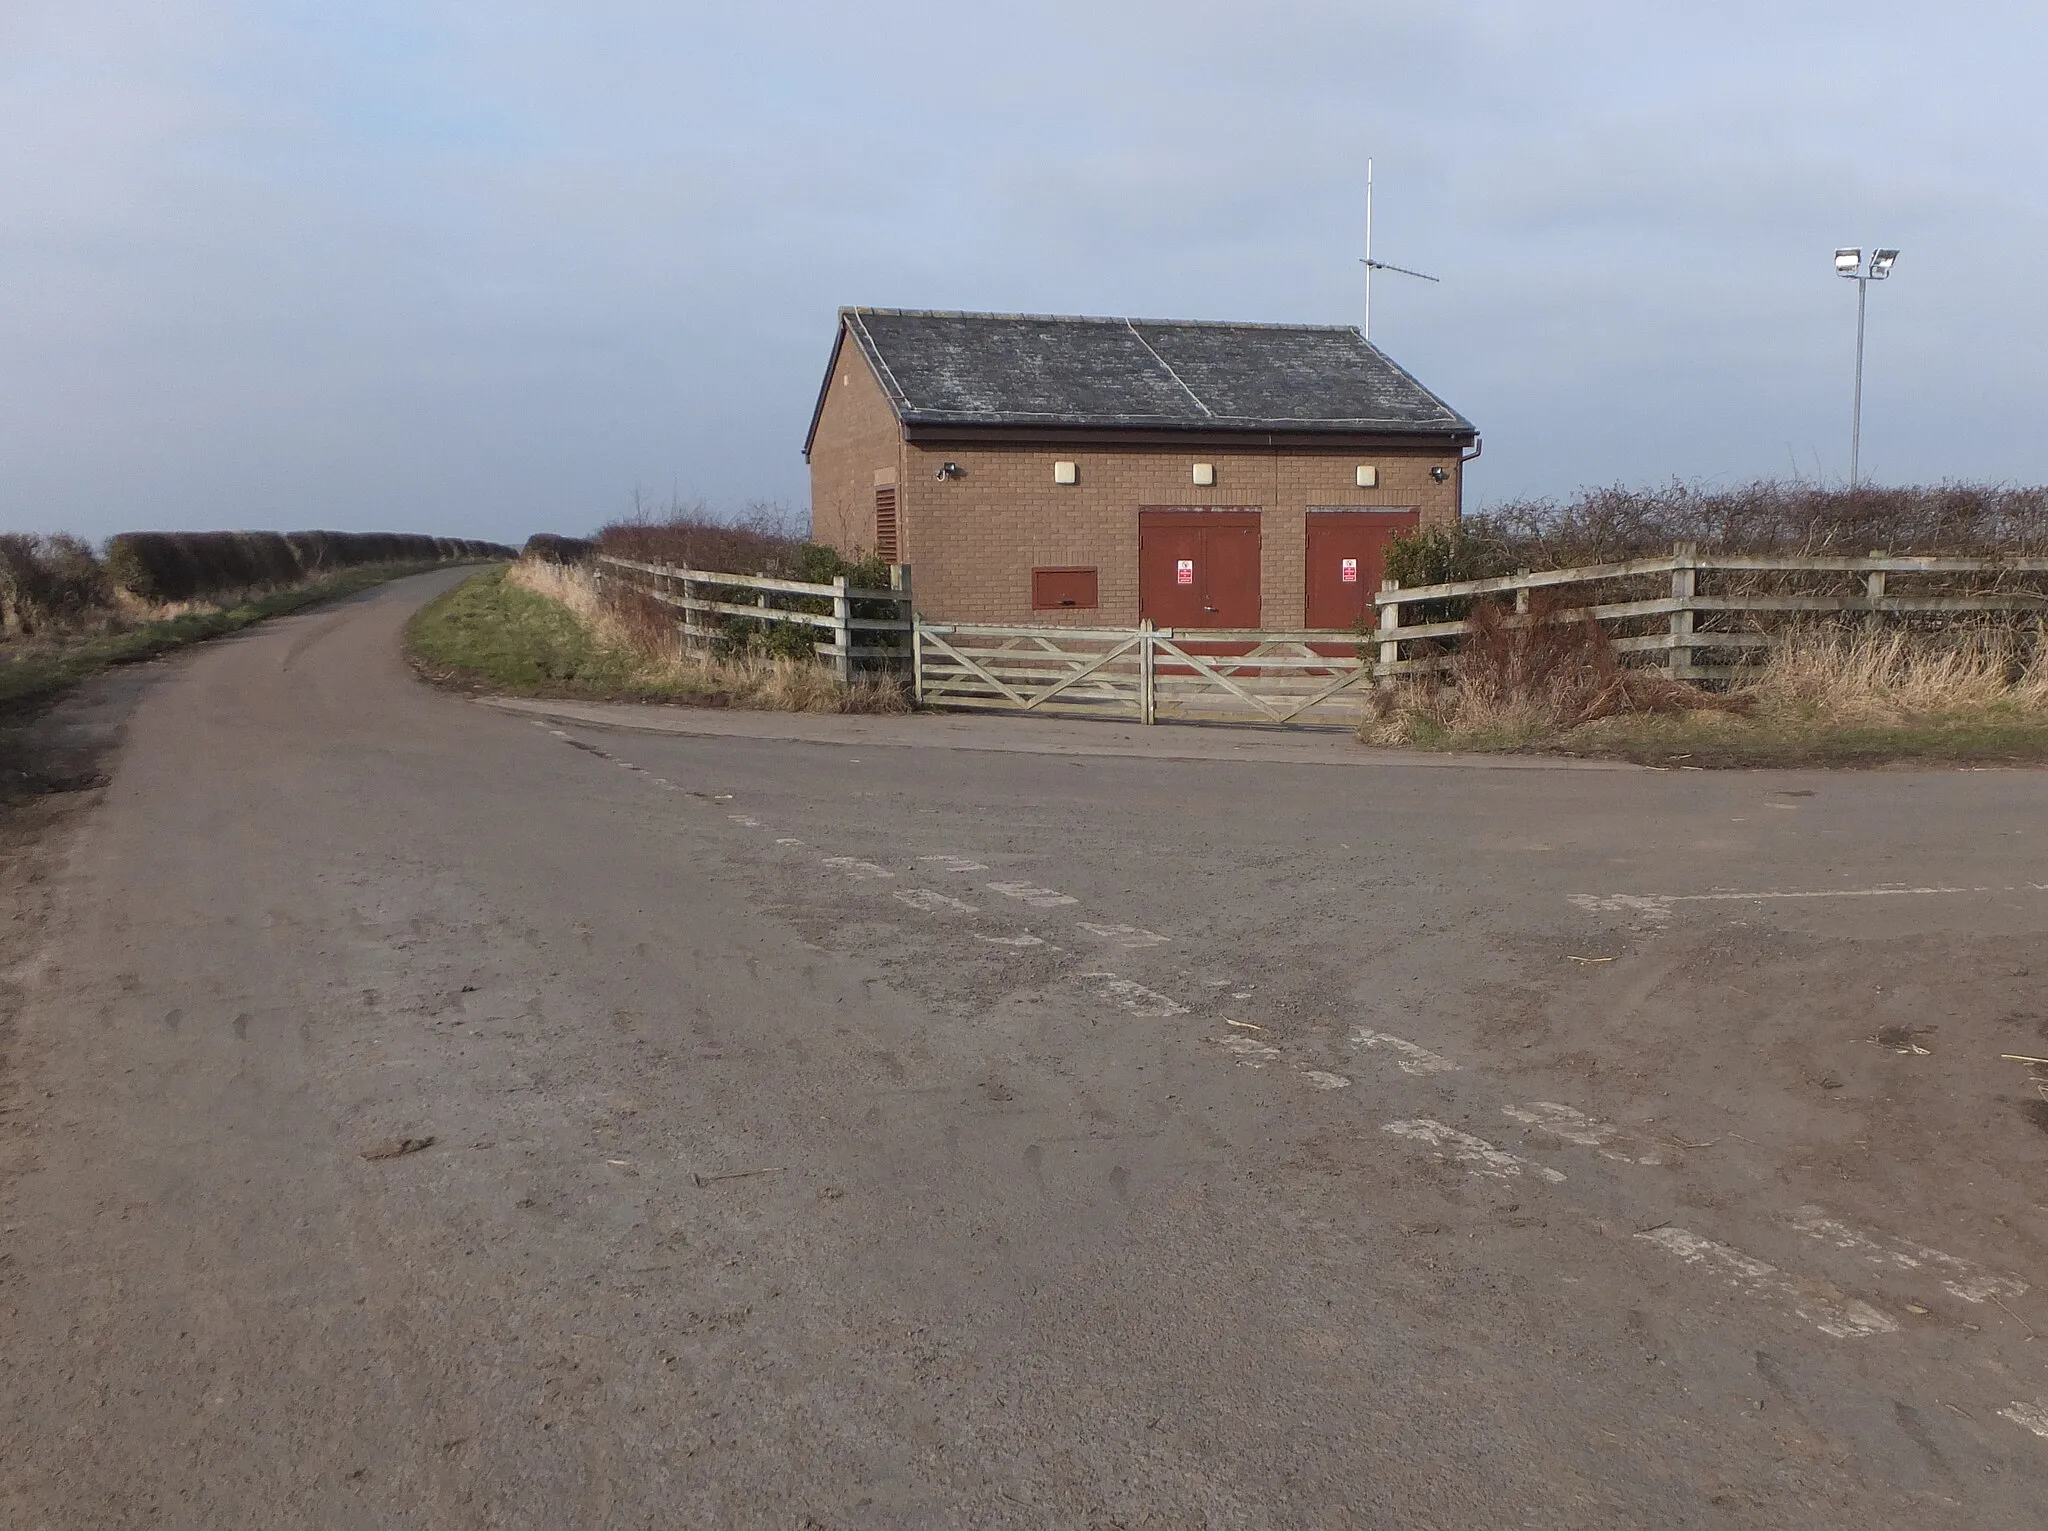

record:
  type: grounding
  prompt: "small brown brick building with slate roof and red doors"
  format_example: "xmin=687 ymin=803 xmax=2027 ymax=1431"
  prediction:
xmin=805 ymin=309 xmax=1479 ymax=630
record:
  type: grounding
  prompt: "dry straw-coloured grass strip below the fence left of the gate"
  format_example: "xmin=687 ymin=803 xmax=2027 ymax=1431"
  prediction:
xmin=506 ymin=559 xmax=909 ymax=712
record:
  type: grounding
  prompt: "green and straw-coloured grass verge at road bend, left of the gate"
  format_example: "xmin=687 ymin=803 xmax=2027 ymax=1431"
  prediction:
xmin=406 ymin=561 xmax=909 ymax=712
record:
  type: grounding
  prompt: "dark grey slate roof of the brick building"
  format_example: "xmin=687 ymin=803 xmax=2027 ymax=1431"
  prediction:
xmin=827 ymin=309 xmax=1475 ymax=446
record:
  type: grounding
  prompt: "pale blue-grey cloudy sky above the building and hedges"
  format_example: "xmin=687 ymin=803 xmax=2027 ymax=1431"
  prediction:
xmin=0 ymin=0 xmax=2048 ymax=540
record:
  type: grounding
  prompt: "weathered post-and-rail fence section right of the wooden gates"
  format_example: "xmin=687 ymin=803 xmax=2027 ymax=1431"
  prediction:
xmin=1372 ymin=542 xmax=2048 ymax=680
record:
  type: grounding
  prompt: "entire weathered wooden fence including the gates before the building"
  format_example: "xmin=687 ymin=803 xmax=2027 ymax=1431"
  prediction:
xmin=598 ymin=542 xmax=2048 ymax=727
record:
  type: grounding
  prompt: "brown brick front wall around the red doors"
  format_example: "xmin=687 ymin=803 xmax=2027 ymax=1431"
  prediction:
xmin=901 ymin=444 xmax=1458 ymax=628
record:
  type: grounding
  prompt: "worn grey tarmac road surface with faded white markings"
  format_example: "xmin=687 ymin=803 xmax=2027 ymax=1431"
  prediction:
xmin=0 ymin=575 xmax=2048 ymax=1531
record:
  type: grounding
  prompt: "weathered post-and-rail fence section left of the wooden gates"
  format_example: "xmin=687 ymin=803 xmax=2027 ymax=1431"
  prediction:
xmin=598 ymin=555 xmax=913 ymax=680
